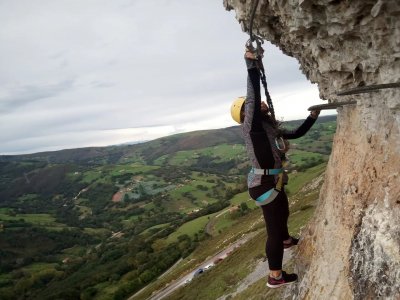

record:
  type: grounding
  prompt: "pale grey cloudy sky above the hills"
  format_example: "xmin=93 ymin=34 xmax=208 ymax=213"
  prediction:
xmin=0 ymin=0 xmax=332 ymax=154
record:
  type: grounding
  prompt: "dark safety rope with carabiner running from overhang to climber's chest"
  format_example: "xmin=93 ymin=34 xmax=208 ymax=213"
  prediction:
xmin=246 ymin=0 xmax=277 ymax=125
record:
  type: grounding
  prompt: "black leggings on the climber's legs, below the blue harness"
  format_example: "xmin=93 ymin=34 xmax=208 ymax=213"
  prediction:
xmin=250 ymin=188 xmax=290 ymax=270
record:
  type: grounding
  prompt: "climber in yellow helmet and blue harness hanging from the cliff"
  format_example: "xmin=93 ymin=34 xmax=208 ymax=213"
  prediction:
xmin=231 ymin=47 xmax=319 ymax=288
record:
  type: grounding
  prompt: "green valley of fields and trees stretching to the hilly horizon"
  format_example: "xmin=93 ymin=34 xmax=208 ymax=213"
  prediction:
xmin=0 ymin=117 xmax=336 ymax=299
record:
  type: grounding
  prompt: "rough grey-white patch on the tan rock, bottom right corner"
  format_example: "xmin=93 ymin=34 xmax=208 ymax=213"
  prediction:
xmin=350 ymin=187 xmax=400 ymax=299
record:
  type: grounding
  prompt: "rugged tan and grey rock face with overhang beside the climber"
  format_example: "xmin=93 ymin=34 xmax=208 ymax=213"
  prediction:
xmin=224 ymin=0 xmax=400 ymax=299
